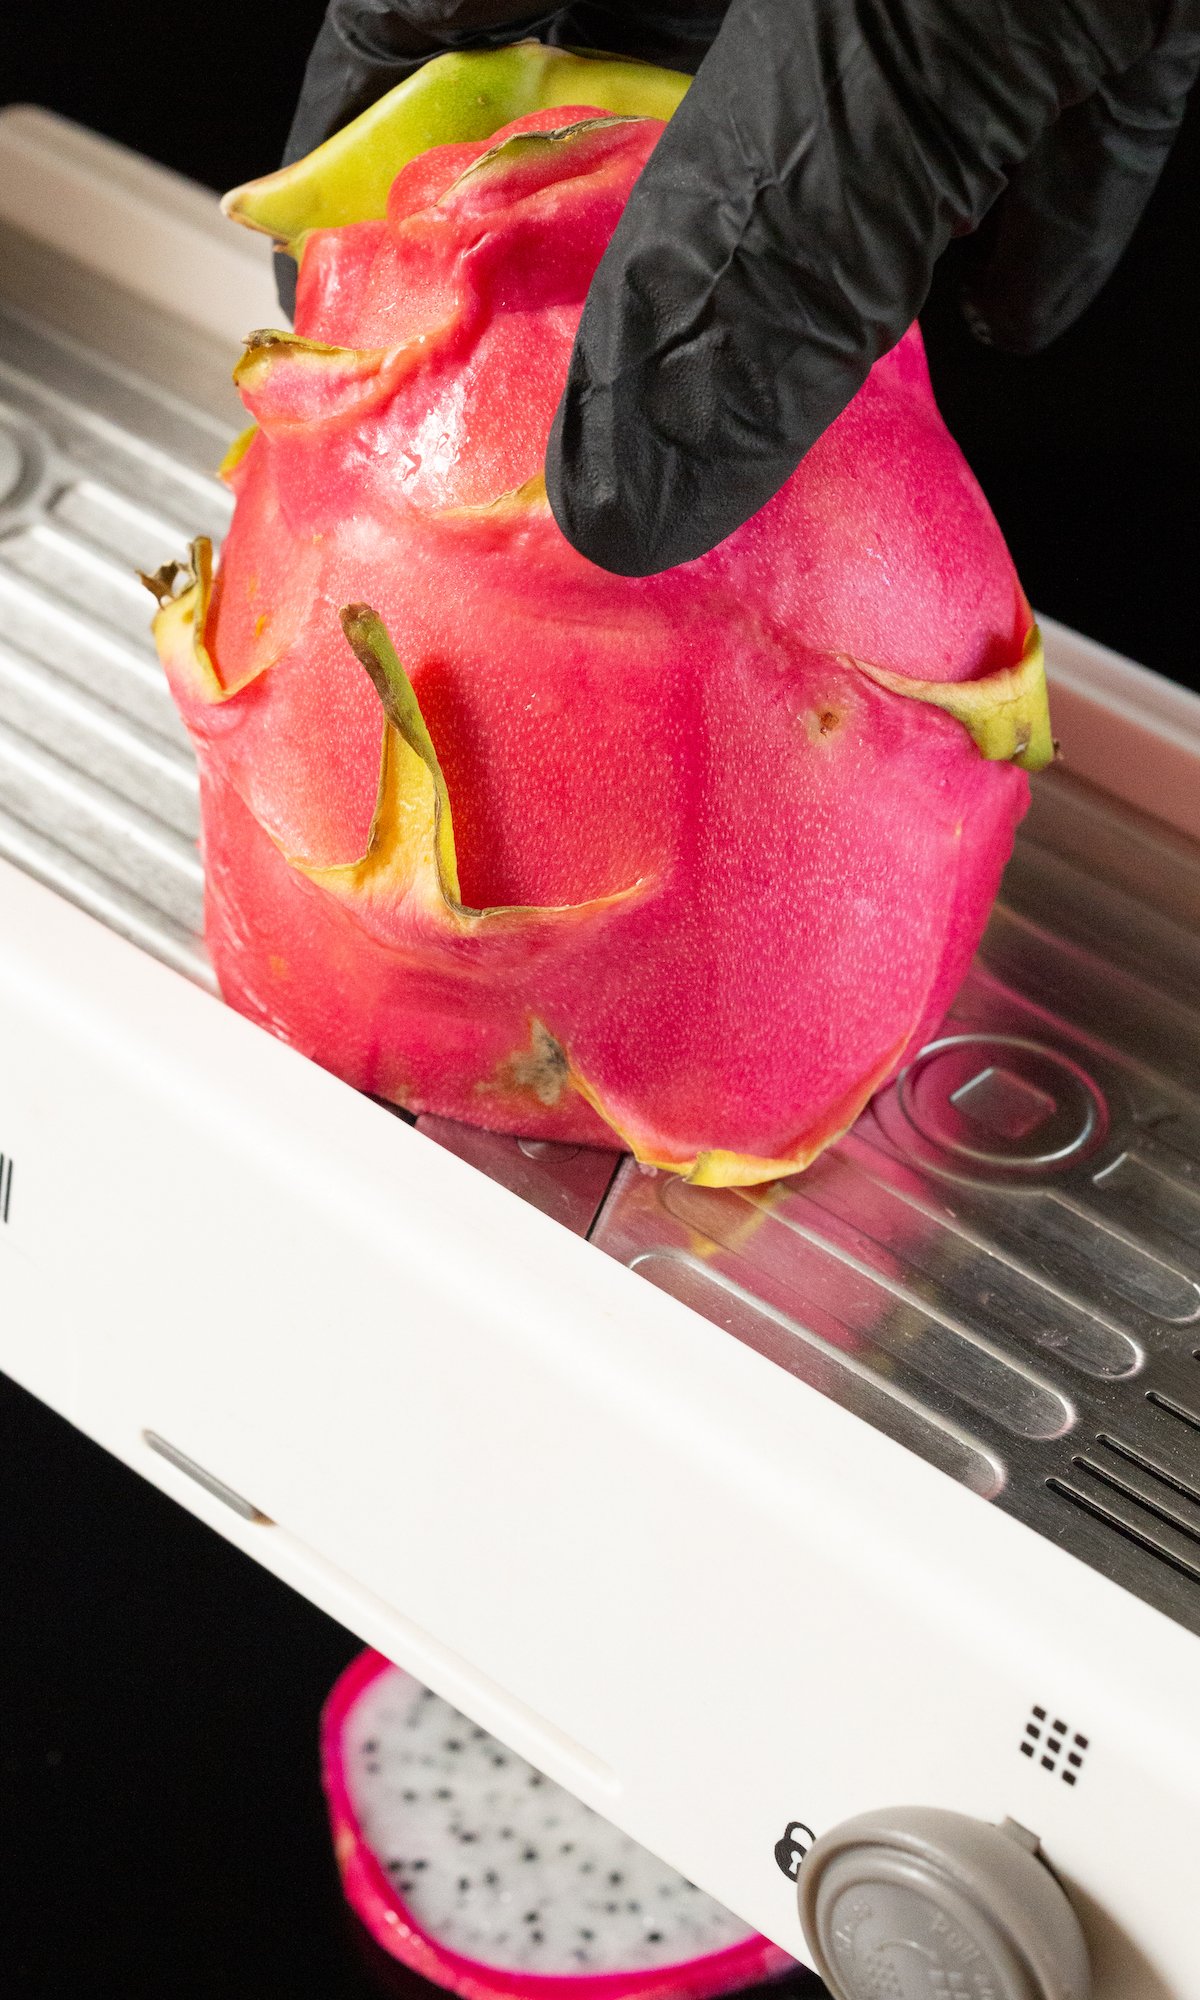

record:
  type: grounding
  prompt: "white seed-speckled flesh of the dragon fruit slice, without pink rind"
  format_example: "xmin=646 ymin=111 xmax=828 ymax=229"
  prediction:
xmin=344 ymin=1670 xmax=754 ymax=1976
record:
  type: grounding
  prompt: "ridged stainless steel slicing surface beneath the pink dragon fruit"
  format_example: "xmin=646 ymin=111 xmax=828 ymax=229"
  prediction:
xmin=0 ymin=232 xmax=1200 ymax=1630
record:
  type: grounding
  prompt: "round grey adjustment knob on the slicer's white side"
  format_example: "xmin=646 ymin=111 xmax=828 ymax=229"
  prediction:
xmin=798 ymin=1806 xmax=1092 ymax=2000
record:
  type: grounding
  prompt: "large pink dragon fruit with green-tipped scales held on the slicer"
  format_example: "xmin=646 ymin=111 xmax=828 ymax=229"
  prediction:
xmin=148 ymin=44 xmax=1052 ymax=1184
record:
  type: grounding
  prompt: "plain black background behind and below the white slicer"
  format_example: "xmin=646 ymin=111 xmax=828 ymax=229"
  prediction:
xmin=0 ymin=0 xmax=1200 ymax=2000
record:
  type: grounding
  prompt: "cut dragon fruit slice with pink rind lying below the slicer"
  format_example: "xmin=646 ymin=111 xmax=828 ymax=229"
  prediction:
xmin=322 ymin=1652 xmax=796 ymax=2000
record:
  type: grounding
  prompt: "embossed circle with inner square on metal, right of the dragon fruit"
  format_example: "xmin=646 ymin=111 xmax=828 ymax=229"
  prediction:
xmin=880 ymin=1034 xmax=1110 ymax=1182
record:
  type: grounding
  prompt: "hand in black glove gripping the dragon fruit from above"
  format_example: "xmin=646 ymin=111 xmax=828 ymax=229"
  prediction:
xmin=286 ymin=0 xmax=1200 ymax=576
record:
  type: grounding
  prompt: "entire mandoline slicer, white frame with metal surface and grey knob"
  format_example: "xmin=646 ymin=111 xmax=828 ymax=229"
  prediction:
xmin=0 ymin=110 xmax=1200 ymax=2000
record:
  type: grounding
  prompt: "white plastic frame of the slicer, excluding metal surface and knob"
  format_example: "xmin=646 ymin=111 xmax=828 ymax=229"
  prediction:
xmin=0 ymin=110 xmax=1200 ymax=2000
